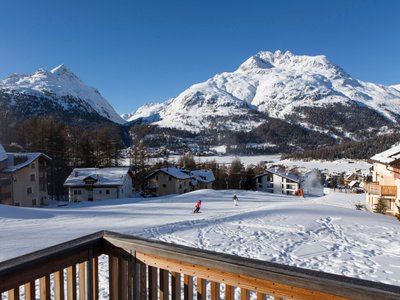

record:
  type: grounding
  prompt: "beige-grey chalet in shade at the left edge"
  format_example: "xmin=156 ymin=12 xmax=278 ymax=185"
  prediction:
xmin=0 ymin=147 xmax=51 ymax=207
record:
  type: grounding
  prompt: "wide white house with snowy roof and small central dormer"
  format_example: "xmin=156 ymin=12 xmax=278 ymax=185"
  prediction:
xmin=64 ymin=168 xmax=133 ymax=202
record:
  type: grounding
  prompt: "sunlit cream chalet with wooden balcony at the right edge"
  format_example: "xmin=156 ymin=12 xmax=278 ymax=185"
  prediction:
xmin=364 ymin=144 xmax=400 ymax=215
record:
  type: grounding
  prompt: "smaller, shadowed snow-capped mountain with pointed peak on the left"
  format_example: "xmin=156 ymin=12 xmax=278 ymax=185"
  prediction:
xmin=0 ymin=65 xmax=125 ymax=124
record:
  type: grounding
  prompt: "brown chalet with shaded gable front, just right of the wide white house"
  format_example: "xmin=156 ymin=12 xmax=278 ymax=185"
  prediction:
xmin=145 ymin=167 xmax=193 ymax=196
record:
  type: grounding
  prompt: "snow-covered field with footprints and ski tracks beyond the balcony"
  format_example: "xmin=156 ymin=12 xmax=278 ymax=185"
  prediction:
xmin=0 ymin=190 xmax=400 ymax=295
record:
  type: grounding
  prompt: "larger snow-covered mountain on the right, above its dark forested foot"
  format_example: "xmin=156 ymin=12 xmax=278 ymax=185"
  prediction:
xmin=128 ymin=50 xmax=400 ymax=132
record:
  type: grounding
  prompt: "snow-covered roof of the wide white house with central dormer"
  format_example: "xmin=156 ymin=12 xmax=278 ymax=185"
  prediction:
xmin=64 ymin=167 xmax=129 ymax=187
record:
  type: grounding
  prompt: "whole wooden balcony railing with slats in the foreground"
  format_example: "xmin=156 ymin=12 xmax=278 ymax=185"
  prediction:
xmin=0 ymin=232 xmax=400 ymax=300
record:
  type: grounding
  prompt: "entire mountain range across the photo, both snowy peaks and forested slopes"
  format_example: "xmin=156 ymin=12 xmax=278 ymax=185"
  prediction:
xmin=0 ymin=51 xmax=400 ymax=153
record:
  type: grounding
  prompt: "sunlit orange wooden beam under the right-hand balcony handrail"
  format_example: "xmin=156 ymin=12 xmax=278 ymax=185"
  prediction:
xmin=136 ymin=252 xmax=346 ymax=300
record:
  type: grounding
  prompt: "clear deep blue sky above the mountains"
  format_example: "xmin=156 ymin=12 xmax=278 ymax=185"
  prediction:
xmin=0 ymin=0 xmax=400 ymax=113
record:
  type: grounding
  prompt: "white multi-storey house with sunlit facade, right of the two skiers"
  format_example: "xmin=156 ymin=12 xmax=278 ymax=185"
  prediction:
xmin=256 ymin=168 xmax=301 ymax=195
